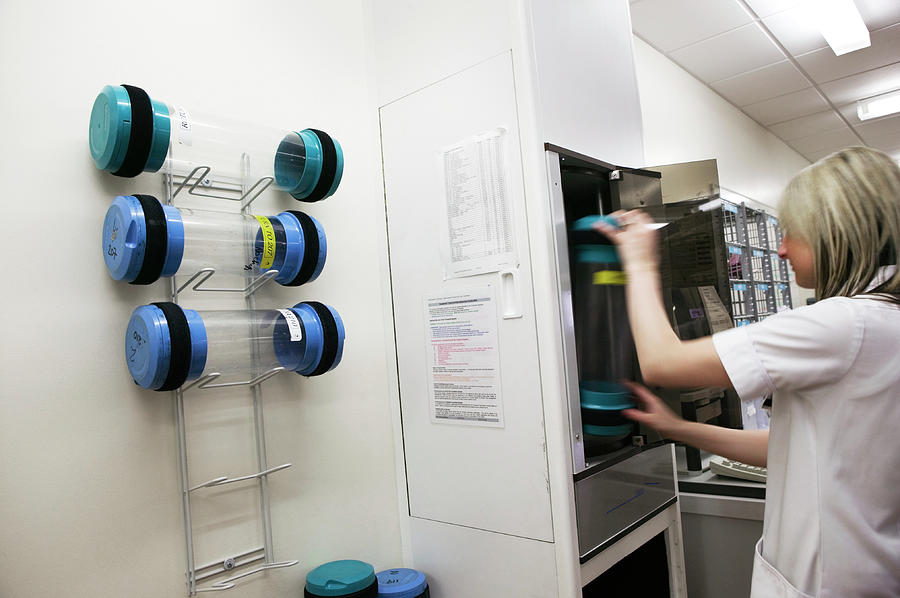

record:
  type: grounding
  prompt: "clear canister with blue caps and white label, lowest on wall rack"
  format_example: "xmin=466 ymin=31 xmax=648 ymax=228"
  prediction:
xmin=125 ymin=301 xmax=345 ymax=390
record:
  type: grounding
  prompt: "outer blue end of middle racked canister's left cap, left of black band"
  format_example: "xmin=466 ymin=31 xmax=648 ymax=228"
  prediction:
xmin=100 ymin=195 xmax=147 ymax=282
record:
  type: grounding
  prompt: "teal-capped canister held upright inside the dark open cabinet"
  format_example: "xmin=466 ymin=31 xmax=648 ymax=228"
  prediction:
xmin=572 ymin=216 xmax=635 ymax=437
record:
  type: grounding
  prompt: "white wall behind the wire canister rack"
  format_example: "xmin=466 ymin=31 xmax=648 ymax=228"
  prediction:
xmin=0 ymin=0 xmax=401 ymax=598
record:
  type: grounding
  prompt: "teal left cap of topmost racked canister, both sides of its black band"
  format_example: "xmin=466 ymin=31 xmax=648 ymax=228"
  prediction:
xmin=88 ymin=85 xmax=171 ymax=172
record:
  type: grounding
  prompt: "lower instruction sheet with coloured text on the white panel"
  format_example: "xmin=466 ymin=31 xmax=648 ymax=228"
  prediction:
xmin=425 ymin=286 xmax=503 ymax=427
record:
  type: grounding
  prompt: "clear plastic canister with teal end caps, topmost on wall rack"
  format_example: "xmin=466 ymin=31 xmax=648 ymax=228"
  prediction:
xmin=89 ymin=85 xmax=344 ymax=202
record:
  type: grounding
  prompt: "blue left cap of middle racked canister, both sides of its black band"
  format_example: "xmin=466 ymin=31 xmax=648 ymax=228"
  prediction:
xmin=101 ymin=195 xmax=184 ymax=282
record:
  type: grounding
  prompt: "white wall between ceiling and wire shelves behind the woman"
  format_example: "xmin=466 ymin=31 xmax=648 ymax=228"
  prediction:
xmin=634 ymin=37 xmax=812 ymax=307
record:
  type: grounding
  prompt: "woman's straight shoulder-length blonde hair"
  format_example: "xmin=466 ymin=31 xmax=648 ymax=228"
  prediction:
xmin=778 ymin=146 xmax=900 ymax=302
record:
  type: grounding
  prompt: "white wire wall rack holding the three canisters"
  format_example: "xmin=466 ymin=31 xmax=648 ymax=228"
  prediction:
xmin=163 ymin=154 xmax=299 ymax=596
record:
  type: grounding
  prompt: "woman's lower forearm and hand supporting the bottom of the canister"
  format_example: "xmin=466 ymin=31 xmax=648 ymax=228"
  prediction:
xmin=622 ymin=383 xmax=769 ymax=467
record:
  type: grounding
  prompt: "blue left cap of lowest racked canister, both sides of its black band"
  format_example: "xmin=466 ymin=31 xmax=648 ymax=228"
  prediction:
xmin=125 ymin=305 xmax=207 ymax=390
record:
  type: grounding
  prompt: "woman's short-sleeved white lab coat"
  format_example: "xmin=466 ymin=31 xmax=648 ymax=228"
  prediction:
xmin=713 ymin=274 xmax=900 ymax=598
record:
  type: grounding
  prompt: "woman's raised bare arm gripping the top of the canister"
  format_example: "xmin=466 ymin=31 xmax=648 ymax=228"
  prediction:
xmin=596 ymin=211 xmax=732 ymax=388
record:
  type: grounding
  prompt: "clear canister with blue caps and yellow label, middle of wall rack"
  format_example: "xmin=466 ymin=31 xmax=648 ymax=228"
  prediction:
xmin=101 ymin=195 xmax=328 ymax=286
